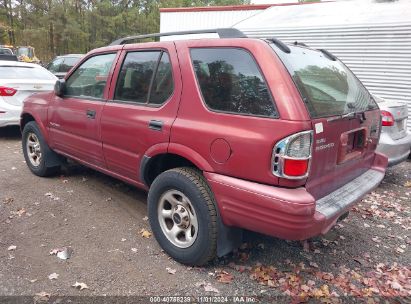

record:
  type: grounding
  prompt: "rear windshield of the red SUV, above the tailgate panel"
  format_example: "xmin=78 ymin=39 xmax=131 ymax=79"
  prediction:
xmin=272 ymin=45 xmax=377 ymax=118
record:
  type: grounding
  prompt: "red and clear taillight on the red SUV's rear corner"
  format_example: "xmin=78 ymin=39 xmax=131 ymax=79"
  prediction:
xmin=272 ymin=131 xmax=313 ymax=179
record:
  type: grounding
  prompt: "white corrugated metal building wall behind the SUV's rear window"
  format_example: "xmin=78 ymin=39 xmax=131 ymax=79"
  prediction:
xmin=235 ymin=0 xmax=411 ymax=131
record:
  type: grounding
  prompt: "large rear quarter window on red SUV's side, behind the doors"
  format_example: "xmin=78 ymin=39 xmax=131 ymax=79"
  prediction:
xmin=191 ymin=48 xmax=278 ymax=117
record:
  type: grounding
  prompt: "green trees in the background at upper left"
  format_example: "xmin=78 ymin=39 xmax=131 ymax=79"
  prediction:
xmin=0 ymin=0 xmax=249 ymax=60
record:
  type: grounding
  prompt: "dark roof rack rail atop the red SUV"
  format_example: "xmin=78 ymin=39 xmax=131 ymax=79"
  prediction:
xmin=109 ymin=28 xmax=247 ymax=45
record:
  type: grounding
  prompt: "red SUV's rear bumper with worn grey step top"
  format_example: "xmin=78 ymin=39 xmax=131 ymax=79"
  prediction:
xmin=205 ymin=153 xmax=387 ymax=240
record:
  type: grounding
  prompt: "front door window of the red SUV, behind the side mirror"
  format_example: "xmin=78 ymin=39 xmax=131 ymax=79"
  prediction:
xmin=65 ymin=53 xmax=116 ymax=98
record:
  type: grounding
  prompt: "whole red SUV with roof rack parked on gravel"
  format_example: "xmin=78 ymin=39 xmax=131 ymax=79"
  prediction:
xmin=21 ymin=29 xmax=387 ymax=265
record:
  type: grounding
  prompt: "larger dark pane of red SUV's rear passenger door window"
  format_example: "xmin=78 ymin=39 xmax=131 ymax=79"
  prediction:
xmin=114 ymin=51 xmax=161 ymax=103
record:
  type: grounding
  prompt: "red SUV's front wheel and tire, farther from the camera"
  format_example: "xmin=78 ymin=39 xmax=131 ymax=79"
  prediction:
xmin=22 ymin=121 xmax=60 ymax=177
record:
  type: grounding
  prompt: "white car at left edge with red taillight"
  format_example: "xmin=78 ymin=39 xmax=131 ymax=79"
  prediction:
xmin=0 ymin=60 xmax=57 ymax=127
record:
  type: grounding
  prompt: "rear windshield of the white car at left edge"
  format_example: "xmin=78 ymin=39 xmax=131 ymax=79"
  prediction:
xmin=0 ymin=66 xmax=56 ymax=80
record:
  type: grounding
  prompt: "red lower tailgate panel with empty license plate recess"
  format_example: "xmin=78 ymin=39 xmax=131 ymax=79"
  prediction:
xmin=306 ymin=110 xmax=380 ymax=199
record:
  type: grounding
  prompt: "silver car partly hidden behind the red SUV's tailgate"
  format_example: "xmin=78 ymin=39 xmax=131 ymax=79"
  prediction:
xmin=374 ymin=95 xmax=411 ymax=166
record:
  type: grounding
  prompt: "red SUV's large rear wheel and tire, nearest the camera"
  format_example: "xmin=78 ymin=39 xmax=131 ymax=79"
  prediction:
xmin=148 ymin=168 xmax=218 ymax=266
